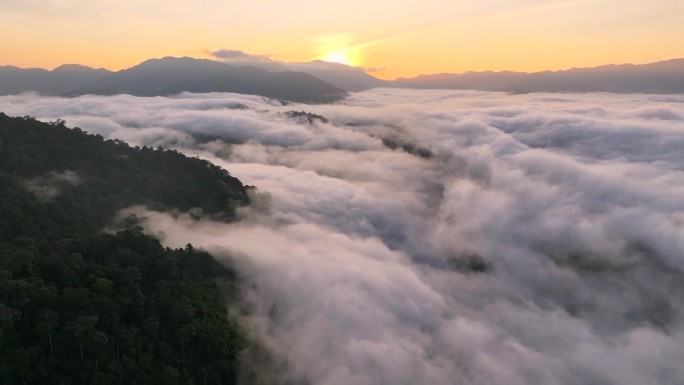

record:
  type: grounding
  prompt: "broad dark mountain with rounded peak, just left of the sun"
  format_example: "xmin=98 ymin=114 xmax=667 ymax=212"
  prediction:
xmin=68 ymin=57 xmax=345 ymax=103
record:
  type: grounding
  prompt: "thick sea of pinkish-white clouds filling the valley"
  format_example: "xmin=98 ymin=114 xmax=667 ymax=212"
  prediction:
xmin=0 ymin=89 xmax=684 ymax=385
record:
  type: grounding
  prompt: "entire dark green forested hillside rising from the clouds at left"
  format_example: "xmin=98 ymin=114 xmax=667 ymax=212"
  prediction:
xmin=0 ymin=113 xmax=248 ymax=384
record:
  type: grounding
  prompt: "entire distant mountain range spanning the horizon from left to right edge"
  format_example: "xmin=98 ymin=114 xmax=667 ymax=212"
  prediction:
xmin=0 ymin=57 xmax=684 ymax=103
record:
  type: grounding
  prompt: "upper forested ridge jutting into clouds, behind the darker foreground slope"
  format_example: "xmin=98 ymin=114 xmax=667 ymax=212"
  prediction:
xmin=0 ymin=113 xmax=248 ymax=224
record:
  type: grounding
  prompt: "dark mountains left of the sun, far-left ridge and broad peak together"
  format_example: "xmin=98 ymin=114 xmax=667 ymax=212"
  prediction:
xmin=0 ymin=57 xmax=346 ymax=103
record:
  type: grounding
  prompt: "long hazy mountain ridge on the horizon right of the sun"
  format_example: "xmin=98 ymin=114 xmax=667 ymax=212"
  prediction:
xmin=394 ymin=59 xmax=684 ymax=94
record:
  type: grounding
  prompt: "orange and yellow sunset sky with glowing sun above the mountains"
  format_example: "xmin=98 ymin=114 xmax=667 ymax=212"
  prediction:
xmin=0 ymin=0 xmax=684 ymax=79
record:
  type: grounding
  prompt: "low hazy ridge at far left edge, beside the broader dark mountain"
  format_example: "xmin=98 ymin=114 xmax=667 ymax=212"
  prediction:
xmin=0 ymin=64 xmax=112 ymax=95
